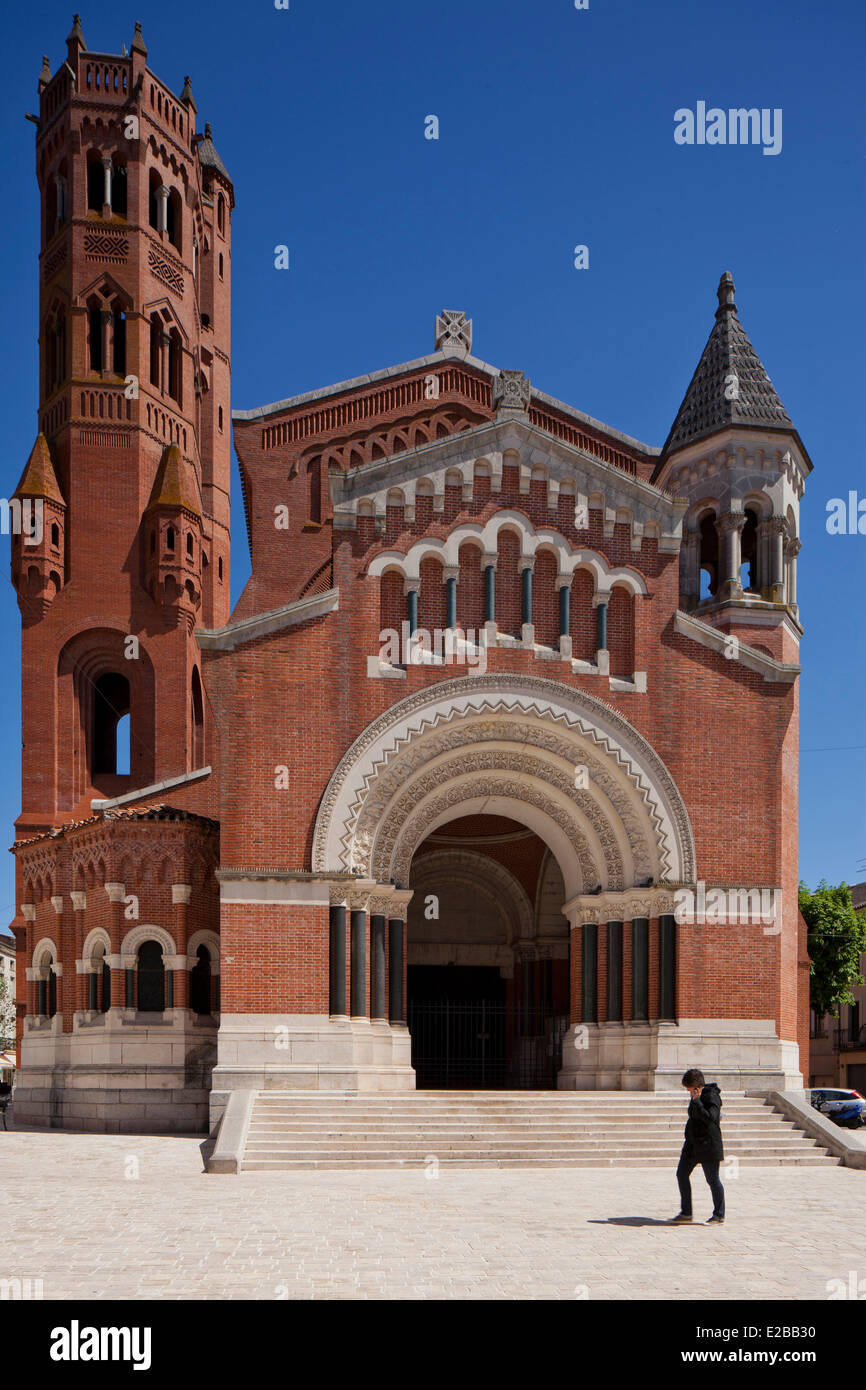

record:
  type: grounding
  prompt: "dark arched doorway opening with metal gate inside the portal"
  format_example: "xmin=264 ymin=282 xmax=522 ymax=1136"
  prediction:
xmin=406 ymin=815 xmax=570 ymax=1090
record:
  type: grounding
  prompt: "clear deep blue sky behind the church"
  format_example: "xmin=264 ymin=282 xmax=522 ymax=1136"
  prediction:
xmin=0 ymin=0 xmax=866 ymax=929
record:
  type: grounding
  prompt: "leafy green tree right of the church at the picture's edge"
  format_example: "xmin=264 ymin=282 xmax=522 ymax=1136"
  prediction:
xmin=799 ymin=878 xmax=866 ymax=1017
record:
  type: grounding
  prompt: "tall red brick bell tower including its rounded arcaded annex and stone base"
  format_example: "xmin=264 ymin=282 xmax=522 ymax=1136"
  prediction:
xmin=13 ymin=15 xmax=234 ymax=1133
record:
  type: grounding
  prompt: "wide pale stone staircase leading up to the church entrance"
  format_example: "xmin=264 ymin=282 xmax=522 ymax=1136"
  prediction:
xmin=233 ymin=1091 xmax=838 ymax=1172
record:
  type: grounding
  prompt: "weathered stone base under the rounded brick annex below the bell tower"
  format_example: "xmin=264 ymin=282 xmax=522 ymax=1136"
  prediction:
xmin=11 ymin=1009 xmax=217 ymax=1134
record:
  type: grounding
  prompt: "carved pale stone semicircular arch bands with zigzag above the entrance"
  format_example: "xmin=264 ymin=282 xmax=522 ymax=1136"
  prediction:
xmin=313 ymin=674 xmax=696 ymax=891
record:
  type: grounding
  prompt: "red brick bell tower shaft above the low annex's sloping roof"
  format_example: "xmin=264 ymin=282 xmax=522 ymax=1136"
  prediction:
xmin=13 ymin=15 xmax=234 ymax=840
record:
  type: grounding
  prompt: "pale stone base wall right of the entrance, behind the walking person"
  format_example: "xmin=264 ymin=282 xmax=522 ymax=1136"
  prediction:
xmin=557 ymin=1019 xmax=803 ymax=1091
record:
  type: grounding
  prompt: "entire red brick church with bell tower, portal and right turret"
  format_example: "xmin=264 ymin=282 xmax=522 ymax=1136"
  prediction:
xmin=13 ymin=19 xmax=810 ymax=1131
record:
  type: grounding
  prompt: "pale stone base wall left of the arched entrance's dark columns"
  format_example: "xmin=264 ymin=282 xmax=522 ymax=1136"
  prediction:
xmin=210 ymin=1013 xmax=416 ymax=1130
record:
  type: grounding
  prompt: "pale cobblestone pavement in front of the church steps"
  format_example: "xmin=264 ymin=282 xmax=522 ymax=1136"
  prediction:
xmin=0 ymin=1130 xmax=866 ymax=1300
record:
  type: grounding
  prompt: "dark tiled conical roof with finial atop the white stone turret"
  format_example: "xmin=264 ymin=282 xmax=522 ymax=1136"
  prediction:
xmin=662 ymin=270 xmax=791 ymax=457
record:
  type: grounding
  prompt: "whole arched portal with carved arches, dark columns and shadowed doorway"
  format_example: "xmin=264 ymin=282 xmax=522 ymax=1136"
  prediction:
xmin=313 ymin=674 xmax=695 ymax=1086
